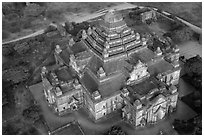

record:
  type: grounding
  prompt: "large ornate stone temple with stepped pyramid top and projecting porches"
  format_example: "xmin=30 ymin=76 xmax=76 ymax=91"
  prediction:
xmin=42 ymin=10 xmax=181 ymax=127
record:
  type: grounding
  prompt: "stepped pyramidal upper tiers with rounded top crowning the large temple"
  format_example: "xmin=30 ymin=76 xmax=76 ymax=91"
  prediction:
xmin=82 ymin=11 xmax=145 ymax=62
